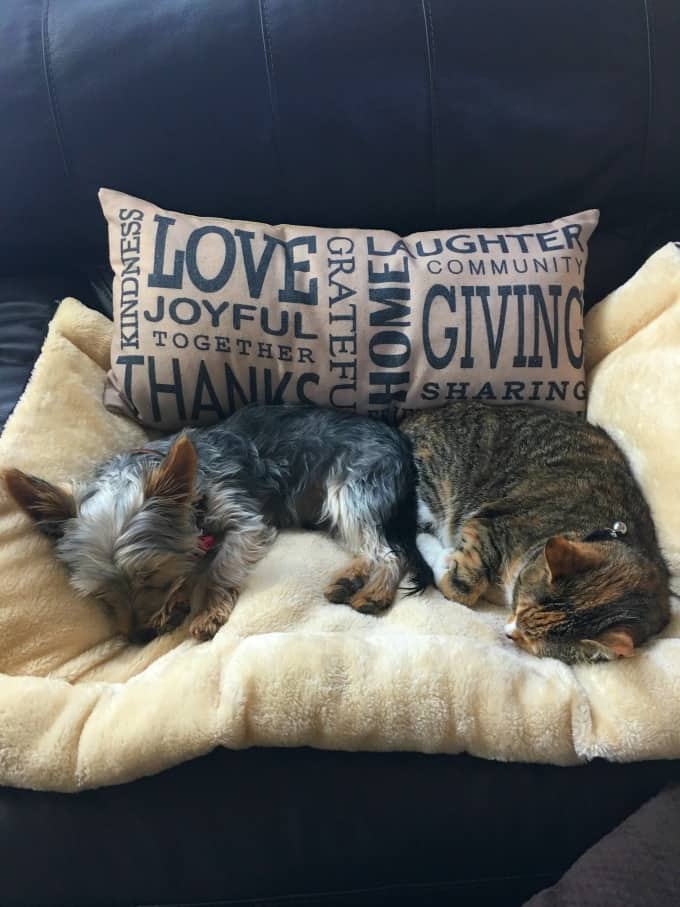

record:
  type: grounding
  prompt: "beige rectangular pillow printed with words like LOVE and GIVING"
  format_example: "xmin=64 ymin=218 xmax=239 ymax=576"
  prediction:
xmin=99 ymin=189 xmax=599 ymax=430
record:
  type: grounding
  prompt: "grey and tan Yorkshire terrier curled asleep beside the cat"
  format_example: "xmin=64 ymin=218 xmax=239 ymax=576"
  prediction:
xmin=4 ymin=404 xmax=427 ymax=643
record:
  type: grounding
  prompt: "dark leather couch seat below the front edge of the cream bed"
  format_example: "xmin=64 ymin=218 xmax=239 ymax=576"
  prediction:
xmin=0 ymin=749 xmax=677 ymax=907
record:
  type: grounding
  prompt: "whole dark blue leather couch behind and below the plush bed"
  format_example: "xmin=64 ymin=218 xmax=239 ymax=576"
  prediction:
xmin=0 ymin=0 xmax=680 ymax=907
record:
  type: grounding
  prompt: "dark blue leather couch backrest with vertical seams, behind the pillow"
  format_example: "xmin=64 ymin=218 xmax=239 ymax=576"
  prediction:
xmin=0 ymin=0 xmax=680 ymax=302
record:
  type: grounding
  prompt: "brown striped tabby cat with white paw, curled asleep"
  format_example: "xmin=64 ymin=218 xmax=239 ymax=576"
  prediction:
xmin=400 ymin=402 xmax=670 ymax=664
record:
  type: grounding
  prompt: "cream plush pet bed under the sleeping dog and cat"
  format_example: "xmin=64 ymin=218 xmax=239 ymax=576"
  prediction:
xmin=0 ymin=246 xmax=680 ymax=791
